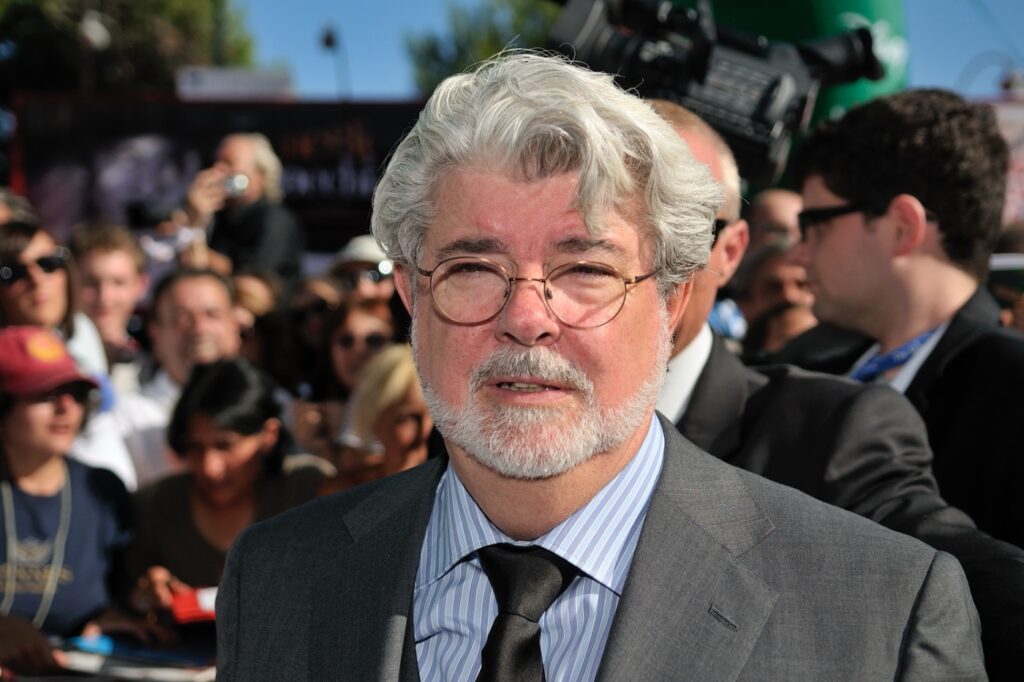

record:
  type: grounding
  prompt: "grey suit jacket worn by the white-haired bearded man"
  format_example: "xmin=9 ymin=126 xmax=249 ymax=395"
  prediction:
xmin=217 ymin=413 xmax=984 ymax=682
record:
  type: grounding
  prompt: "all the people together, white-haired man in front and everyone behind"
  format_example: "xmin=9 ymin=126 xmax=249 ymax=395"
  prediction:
xmin=0 ymin=53 xmax=1024 ymax=680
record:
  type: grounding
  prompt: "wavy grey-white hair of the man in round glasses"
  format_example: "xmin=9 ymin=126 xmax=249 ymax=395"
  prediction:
xmin=371 ymin=50 xmax=721 ymax=294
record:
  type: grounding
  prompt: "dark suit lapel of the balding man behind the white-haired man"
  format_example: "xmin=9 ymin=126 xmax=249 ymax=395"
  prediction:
xmin=678 ymin=334 xmax=768 ymax=461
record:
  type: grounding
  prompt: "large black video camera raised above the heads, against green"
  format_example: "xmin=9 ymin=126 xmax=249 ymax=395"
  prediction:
xmin=551 ymin=0 xmax=885 ymax=186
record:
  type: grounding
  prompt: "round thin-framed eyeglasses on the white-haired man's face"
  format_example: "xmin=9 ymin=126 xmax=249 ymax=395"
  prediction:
xmin=416 ymin=256 xmax=657 ymax=329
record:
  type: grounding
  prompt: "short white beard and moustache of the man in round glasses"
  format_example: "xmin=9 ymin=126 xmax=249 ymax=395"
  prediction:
xmin=412 ymin=307 xmax=672 ymax=479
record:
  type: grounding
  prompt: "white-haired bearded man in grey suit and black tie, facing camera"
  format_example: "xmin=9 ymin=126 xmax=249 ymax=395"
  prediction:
xmin=217 ymin=52 xmax=984 ymax=680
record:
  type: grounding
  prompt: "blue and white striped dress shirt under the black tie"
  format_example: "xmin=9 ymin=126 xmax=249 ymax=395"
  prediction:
xmin=413 ymin=419 xmax=665 ymax=682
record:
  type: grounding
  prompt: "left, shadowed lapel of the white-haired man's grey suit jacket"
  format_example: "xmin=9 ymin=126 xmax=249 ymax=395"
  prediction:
xmin=308 ymin=458 xmax=447 ymax=681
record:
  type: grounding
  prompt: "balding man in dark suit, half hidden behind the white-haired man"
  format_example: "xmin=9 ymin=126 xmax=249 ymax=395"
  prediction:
xmin=651 ymin=100 xmax=1024 ymax=680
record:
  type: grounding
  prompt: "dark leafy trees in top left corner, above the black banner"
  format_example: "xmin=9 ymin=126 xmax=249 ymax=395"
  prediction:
xmin=0 ymin=0 xmax=253 ymax=101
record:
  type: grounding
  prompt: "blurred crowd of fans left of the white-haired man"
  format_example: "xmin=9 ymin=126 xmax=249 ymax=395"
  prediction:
xmin=0 ymin=135 xmax=433 ymax=673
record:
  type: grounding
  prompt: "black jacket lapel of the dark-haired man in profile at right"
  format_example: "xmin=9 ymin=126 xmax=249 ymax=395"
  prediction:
xmin=904 ymin=287 xmax=999 ymax=414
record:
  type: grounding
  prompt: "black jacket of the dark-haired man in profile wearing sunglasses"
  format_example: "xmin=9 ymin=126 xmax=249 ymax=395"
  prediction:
xmin=772 ymin=288 xmax=1024 ymax=547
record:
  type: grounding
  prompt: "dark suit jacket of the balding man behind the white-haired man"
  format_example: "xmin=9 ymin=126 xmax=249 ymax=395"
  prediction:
xmin=677 ymin=336 xmax=1024 ymax=680
